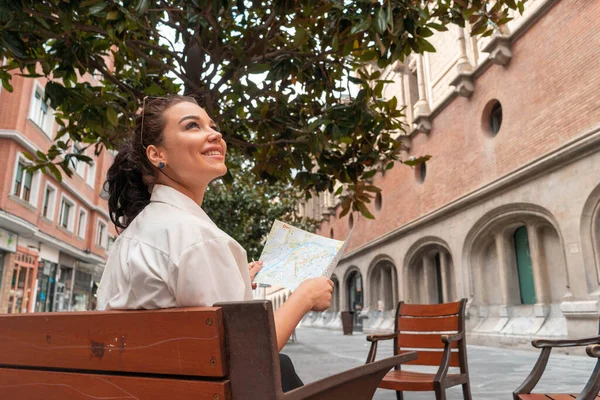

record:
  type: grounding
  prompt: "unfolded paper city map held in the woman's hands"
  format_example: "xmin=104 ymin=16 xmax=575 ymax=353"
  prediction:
xmin=254 ymin=221 xmax=350 ymax=290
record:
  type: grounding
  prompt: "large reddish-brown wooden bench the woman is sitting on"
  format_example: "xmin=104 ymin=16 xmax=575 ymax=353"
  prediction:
xmin=0 ymin=301 xmax=416 ymax=400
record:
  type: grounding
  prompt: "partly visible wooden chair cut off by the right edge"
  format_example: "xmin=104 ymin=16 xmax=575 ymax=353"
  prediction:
xmin=513 ymin=336 xmax=600 ymax=400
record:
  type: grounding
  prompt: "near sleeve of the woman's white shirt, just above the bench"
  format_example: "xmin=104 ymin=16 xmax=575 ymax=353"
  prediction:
xmin=169 ymin=238 xmax=248 ymax=307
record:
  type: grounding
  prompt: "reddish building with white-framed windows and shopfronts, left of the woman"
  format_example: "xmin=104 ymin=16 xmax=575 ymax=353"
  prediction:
xmin=0 ymin=72 xmax=115 ymax=313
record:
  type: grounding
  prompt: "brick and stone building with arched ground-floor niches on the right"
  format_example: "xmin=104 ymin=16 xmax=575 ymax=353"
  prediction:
xmin=304 ymin=0 xmax=600 ymax=345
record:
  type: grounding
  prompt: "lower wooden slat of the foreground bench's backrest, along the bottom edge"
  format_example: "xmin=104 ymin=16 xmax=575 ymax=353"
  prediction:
xmin=0 ymin=368 xmax=230 ymax=400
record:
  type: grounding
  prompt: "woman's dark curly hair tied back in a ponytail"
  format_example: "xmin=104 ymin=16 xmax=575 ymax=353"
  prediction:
xmin=105 ymin=95 xmax=198 ymax=229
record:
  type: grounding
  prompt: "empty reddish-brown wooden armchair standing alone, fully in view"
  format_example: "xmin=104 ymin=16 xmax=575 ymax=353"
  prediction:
xmin=367 ymin=299 xmax=471 ymax=400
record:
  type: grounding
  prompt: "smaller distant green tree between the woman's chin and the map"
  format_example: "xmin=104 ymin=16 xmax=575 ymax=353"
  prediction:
xmin=202 ymin=156 xmax=319 ymax=260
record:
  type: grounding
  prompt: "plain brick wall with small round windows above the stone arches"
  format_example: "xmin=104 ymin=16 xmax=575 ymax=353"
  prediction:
xmin=320 ymin=0 xmax=600 ymax=250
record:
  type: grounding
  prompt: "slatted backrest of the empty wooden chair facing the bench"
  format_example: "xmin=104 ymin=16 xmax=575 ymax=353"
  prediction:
xmin=394 ymin=299 xmax=466 ymax=369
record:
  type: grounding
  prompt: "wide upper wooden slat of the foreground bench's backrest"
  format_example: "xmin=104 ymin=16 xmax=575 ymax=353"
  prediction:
xmin=0 ymin=307 xmax=227 ymax=377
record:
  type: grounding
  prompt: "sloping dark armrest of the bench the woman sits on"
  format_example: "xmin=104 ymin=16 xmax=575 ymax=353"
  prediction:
xmin=281 ymin=351 xmax=417 ymax=400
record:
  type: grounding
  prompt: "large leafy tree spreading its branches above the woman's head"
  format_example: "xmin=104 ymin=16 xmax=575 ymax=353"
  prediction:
xmin=0 ymin=0 xmax=526 ymax=216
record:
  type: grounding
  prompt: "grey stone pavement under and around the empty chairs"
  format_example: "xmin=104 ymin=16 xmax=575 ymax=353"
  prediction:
xmin=282 ymin=328 xmax=596 ymax=400
